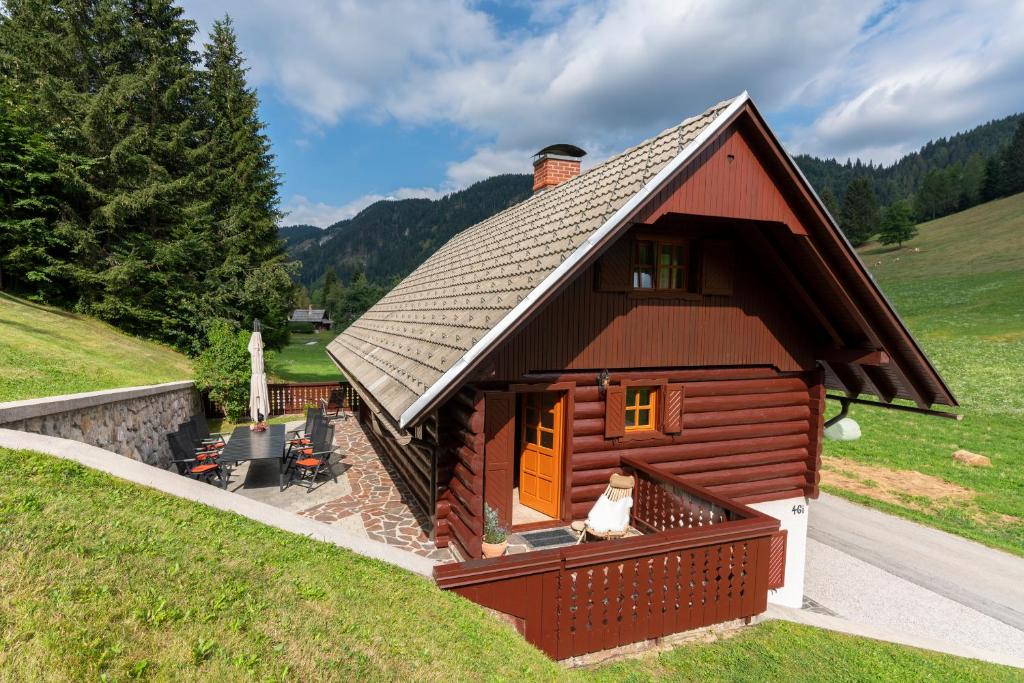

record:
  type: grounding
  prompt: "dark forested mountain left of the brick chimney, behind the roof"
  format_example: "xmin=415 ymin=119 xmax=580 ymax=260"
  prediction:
xmin=281 ymin=174 xmax=534 ymax=289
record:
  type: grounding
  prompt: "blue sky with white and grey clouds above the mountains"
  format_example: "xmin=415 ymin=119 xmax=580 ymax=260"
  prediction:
xmin=182 ymin=0 xmax=1024 ymax=226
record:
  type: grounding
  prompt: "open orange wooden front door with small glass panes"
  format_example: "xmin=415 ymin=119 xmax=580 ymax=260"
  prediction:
xmin=519 ymin=391 xmax=563 ymax=518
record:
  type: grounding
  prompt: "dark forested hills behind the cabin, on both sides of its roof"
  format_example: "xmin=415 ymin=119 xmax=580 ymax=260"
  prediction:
xmin=281 ymin=114 xmax=1024 ymax=309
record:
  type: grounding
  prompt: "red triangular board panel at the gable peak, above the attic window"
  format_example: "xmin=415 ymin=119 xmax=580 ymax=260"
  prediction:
xmin=635 ymin=127 xmax=807 ymax=234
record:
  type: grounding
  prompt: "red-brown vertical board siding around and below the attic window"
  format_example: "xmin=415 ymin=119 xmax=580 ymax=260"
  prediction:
xmin=487 ymin=243 xmax=816 ymax=381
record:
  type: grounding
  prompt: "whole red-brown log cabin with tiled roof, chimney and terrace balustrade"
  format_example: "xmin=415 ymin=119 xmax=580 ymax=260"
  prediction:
xmin=328 ymin=93 xmax=956 ymax=658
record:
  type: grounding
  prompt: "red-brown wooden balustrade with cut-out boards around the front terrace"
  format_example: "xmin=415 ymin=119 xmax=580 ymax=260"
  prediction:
xmin=434 ymin=458 xmax=778 ymax=659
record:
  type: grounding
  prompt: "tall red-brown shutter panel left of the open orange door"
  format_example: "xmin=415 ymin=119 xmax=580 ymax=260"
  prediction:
xmin=483 ymin=391 xmax=515 ymax=528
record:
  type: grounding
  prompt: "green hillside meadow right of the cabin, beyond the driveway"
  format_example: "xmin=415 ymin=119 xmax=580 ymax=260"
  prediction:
xmin=823 ymin=195 xmax=1024 ymax=555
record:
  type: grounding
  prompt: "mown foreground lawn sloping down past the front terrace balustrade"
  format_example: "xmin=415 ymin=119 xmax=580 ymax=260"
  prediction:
xmin=0 ymin=450 xmax=1021 ymax=681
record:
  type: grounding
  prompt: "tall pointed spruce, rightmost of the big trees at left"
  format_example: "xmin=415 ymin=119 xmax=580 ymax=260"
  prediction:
xmin=202 ymin=16 xmax=291 ymax=346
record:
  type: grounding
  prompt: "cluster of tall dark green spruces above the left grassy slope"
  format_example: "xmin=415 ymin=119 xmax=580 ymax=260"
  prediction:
xmin=0 ymin=0 xmax=295 ymax=353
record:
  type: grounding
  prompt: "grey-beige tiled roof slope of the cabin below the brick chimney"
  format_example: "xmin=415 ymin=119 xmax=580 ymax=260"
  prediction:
xmin=328 ymin=94 xmax=745 ymax=422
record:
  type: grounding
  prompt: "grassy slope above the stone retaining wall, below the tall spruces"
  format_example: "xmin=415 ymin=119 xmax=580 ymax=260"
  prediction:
xmin=0 ymin=293 xmax=191 ymax=401
